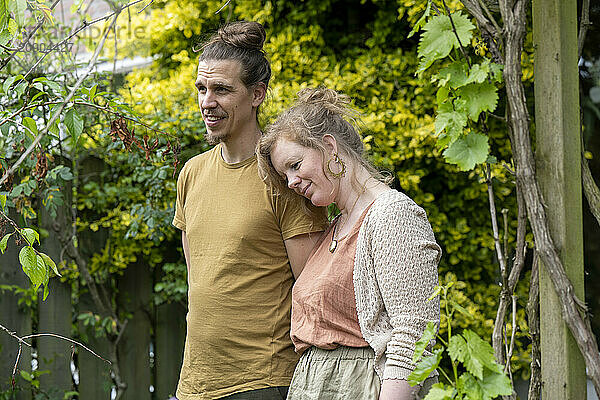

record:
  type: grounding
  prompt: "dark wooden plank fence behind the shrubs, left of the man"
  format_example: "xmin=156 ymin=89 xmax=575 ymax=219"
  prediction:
xmin=0 ymin=222 xmax=185 ymax=400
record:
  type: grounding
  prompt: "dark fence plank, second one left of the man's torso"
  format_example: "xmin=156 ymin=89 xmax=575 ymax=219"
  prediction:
xmin=118 ymin=262 xmax=152 ymax=400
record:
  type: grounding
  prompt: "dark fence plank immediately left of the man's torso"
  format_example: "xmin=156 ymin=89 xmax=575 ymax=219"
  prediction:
xmin=154 ymin=303 xmax=186 ymax=400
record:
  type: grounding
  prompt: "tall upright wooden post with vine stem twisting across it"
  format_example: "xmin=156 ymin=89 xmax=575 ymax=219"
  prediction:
xmin=533 ymin=0 xmax=586 ymax=400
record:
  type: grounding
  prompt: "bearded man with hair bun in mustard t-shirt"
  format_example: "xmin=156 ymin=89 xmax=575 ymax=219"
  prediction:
xmin=173 ymin=21 xmax=326 ymax=400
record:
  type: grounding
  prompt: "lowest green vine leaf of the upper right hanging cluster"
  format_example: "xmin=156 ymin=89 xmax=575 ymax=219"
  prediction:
xmin=443 ymin=132 xmax=490 ymax=171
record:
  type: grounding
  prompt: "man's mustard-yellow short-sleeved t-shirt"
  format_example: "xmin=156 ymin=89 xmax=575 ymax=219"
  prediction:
xmin=173 ymin=145 xmax=326 ymax=400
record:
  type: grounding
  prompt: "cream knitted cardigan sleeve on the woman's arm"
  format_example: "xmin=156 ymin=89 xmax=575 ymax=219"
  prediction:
xmin=368 ymin=197 xmax=441 ymax=379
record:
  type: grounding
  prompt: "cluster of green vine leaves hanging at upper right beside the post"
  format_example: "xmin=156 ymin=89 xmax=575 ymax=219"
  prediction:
xmin=414 ymin=0 xmax=501 ymax=171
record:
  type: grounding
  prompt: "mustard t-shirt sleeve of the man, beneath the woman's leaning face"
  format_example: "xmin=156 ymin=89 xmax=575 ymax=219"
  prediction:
xmin=275 ymin=193 xmax=328 ymax=240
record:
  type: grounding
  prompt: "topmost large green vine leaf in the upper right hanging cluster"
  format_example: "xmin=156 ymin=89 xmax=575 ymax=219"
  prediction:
xmin=417 ymin=12 xmax=475 ymax=74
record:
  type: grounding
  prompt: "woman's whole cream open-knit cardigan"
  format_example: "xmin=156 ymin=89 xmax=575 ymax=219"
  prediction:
xmin=354 ymin=190 xmax=442 ymax=380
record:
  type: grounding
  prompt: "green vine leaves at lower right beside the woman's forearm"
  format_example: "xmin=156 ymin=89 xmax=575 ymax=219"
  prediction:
xmin=408 ymin=282 xmax=512 ymax=400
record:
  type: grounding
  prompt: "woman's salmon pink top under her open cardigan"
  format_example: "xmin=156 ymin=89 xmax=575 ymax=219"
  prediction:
xmin=290 ymin=206 xmax=371 ymax=354
